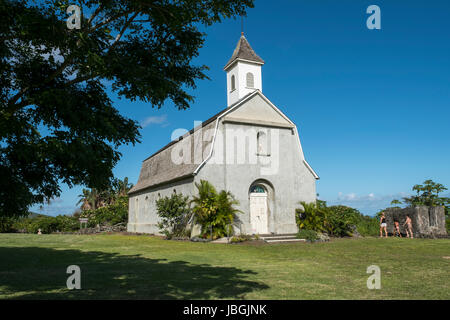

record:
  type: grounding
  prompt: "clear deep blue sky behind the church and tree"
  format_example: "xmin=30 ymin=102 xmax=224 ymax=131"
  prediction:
xmin=32 ymin=0 xmax=450 ymax=215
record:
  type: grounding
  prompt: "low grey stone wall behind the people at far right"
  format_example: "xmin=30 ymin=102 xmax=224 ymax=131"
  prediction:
xmin=385 ymin=206 xmax=447 ymax=238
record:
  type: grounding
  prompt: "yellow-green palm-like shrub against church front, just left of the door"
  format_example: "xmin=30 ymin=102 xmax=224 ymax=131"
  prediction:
xmin=191 ymin=180 xmax=240 ymax=238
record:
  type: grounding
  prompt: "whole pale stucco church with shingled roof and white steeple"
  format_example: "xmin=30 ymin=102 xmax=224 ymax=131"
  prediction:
xmin=128 ymin=34 xmax=319 ymax=235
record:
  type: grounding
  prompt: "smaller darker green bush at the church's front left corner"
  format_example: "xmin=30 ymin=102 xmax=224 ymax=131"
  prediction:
xmin=156 ymin=194 xmax=191 ymax=238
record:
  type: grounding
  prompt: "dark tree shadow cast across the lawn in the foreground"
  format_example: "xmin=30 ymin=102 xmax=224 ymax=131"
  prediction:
xmin=0 ymin=247 xmax=268 ymax=299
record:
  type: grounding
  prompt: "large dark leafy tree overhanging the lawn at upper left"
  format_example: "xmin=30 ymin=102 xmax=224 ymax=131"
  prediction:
xmin=0 ymin=0 xmax=253 ymax=216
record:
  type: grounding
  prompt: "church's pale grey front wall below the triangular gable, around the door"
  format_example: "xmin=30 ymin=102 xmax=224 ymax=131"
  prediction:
xmin=195 ymin=122 xmax=316 ymax=234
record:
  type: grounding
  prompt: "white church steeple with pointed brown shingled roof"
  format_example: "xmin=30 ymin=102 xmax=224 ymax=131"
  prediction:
xmin=224 ymin=33 xmax=264 ymax=106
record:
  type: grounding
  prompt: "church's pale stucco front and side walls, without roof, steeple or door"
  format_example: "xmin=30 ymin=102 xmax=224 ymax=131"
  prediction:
xmin=128 ymin=93 xmax=316 ymax=234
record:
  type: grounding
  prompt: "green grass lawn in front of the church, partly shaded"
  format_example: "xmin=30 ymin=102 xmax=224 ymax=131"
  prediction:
xmin=0 ymin=234 xmax=450 ymax=299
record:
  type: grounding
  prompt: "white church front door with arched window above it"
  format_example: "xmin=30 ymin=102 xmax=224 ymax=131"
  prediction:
xmin=250 ymin=184 xmax=269 ymax=234
